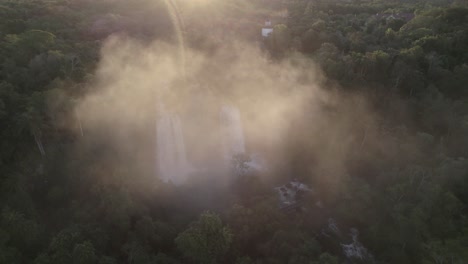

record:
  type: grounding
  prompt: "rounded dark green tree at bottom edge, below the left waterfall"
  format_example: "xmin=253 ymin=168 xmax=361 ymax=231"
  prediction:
xmin=175 ymin=212 xmax=232 ymax=264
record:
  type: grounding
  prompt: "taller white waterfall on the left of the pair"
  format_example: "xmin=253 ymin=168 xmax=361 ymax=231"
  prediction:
xmin=156 ymin=103 xmax=190 ymax=184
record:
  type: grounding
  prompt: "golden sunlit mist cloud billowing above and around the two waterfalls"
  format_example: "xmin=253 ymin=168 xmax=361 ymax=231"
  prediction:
xmin=77 ymin=37 xmax=398 ymax=192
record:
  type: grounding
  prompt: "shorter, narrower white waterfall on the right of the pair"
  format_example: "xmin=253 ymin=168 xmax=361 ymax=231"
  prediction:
xmin=220 ymin=105 xmax=245 ymax=162
